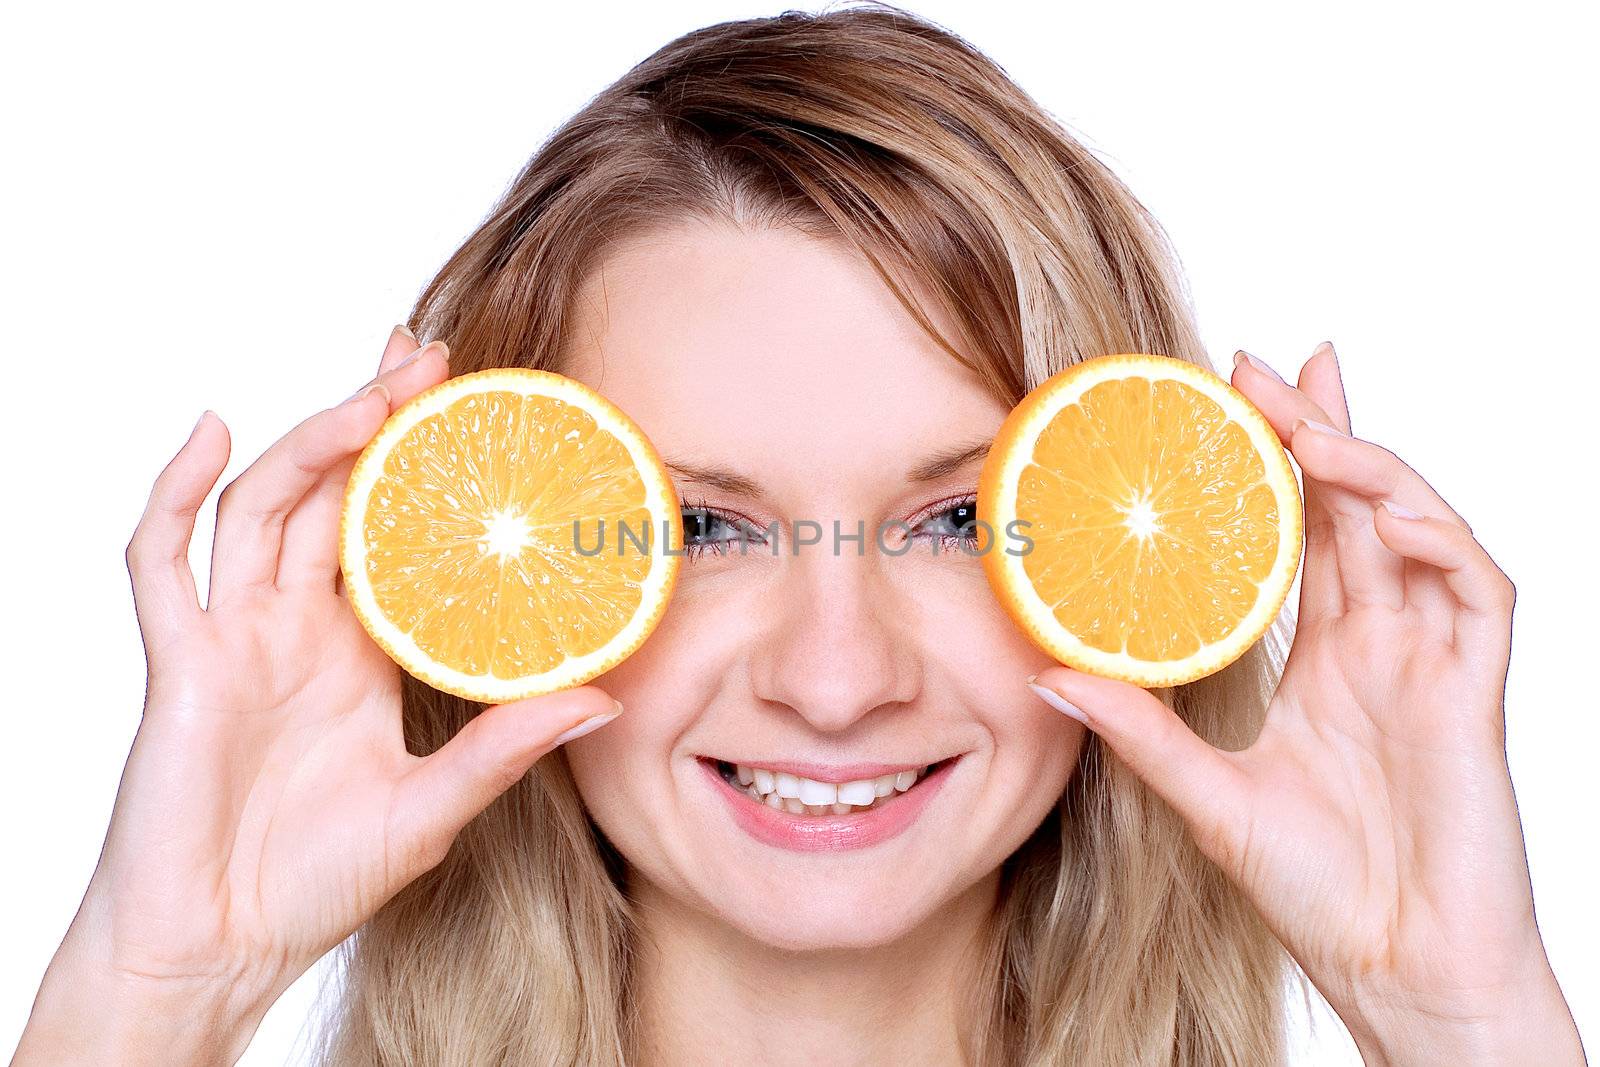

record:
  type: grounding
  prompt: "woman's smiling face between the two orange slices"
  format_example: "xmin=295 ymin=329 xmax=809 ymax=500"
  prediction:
xmin=562 ymin=222 xmax=1083 ymax=949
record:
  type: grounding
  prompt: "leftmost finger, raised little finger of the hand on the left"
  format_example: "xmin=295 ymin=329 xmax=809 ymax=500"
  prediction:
xmin=126 ymin=411 xmax=229 ymax=656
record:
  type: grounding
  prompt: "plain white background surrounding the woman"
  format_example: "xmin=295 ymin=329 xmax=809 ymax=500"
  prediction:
xmin=0 ymin=0 xmax=1600 ymax=1064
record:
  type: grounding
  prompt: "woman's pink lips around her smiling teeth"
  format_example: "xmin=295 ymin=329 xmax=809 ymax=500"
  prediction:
xmin=699 ymin=760 xmax=957 ymax=853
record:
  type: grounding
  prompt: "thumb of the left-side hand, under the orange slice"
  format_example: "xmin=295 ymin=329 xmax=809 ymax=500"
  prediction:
xmin=392 ymin=686 xmax=622 ymax=870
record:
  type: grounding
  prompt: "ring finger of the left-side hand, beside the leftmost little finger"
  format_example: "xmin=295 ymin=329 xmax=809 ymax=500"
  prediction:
xmin=208 ymin=382 xmax=389 ymax=606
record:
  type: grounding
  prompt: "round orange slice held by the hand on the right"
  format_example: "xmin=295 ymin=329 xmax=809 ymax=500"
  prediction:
xmin=978 ymin=354 xmax=1304 ymax=688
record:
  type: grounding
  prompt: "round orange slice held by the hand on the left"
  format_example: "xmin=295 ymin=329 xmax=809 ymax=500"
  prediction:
xmin=339 ymin=368 xmax=683 ymax=702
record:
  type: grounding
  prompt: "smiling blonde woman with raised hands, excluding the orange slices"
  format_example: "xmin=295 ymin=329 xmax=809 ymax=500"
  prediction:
xmin=18 ymin=8 xmax=1582 ymax=1064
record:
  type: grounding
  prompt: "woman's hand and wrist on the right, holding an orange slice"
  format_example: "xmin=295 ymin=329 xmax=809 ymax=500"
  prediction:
xmin=1037 ymin=344 xmax=1584 ymax=1065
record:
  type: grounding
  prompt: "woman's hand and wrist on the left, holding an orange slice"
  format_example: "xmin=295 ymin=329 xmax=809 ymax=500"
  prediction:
xmin=14 ymin=328 xmax=619 ymax=1064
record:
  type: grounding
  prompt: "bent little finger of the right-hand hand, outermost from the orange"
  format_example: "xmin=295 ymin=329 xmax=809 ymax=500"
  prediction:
xmin=1373 ymin=501 xmax=1517 ymax=657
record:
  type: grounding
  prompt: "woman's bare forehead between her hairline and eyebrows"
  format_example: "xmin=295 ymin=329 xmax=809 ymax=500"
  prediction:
xmin=560 ymin=221 xmax=1006 ymax=476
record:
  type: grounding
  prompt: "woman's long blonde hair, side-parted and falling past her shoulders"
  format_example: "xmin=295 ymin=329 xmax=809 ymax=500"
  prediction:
xmin=322 ymin=5 xmax=1286 ymax=1067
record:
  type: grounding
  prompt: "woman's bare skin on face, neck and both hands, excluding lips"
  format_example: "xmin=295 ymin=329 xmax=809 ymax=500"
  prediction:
xmin=14 ymin=222 xmax=1582 ymax=1064
